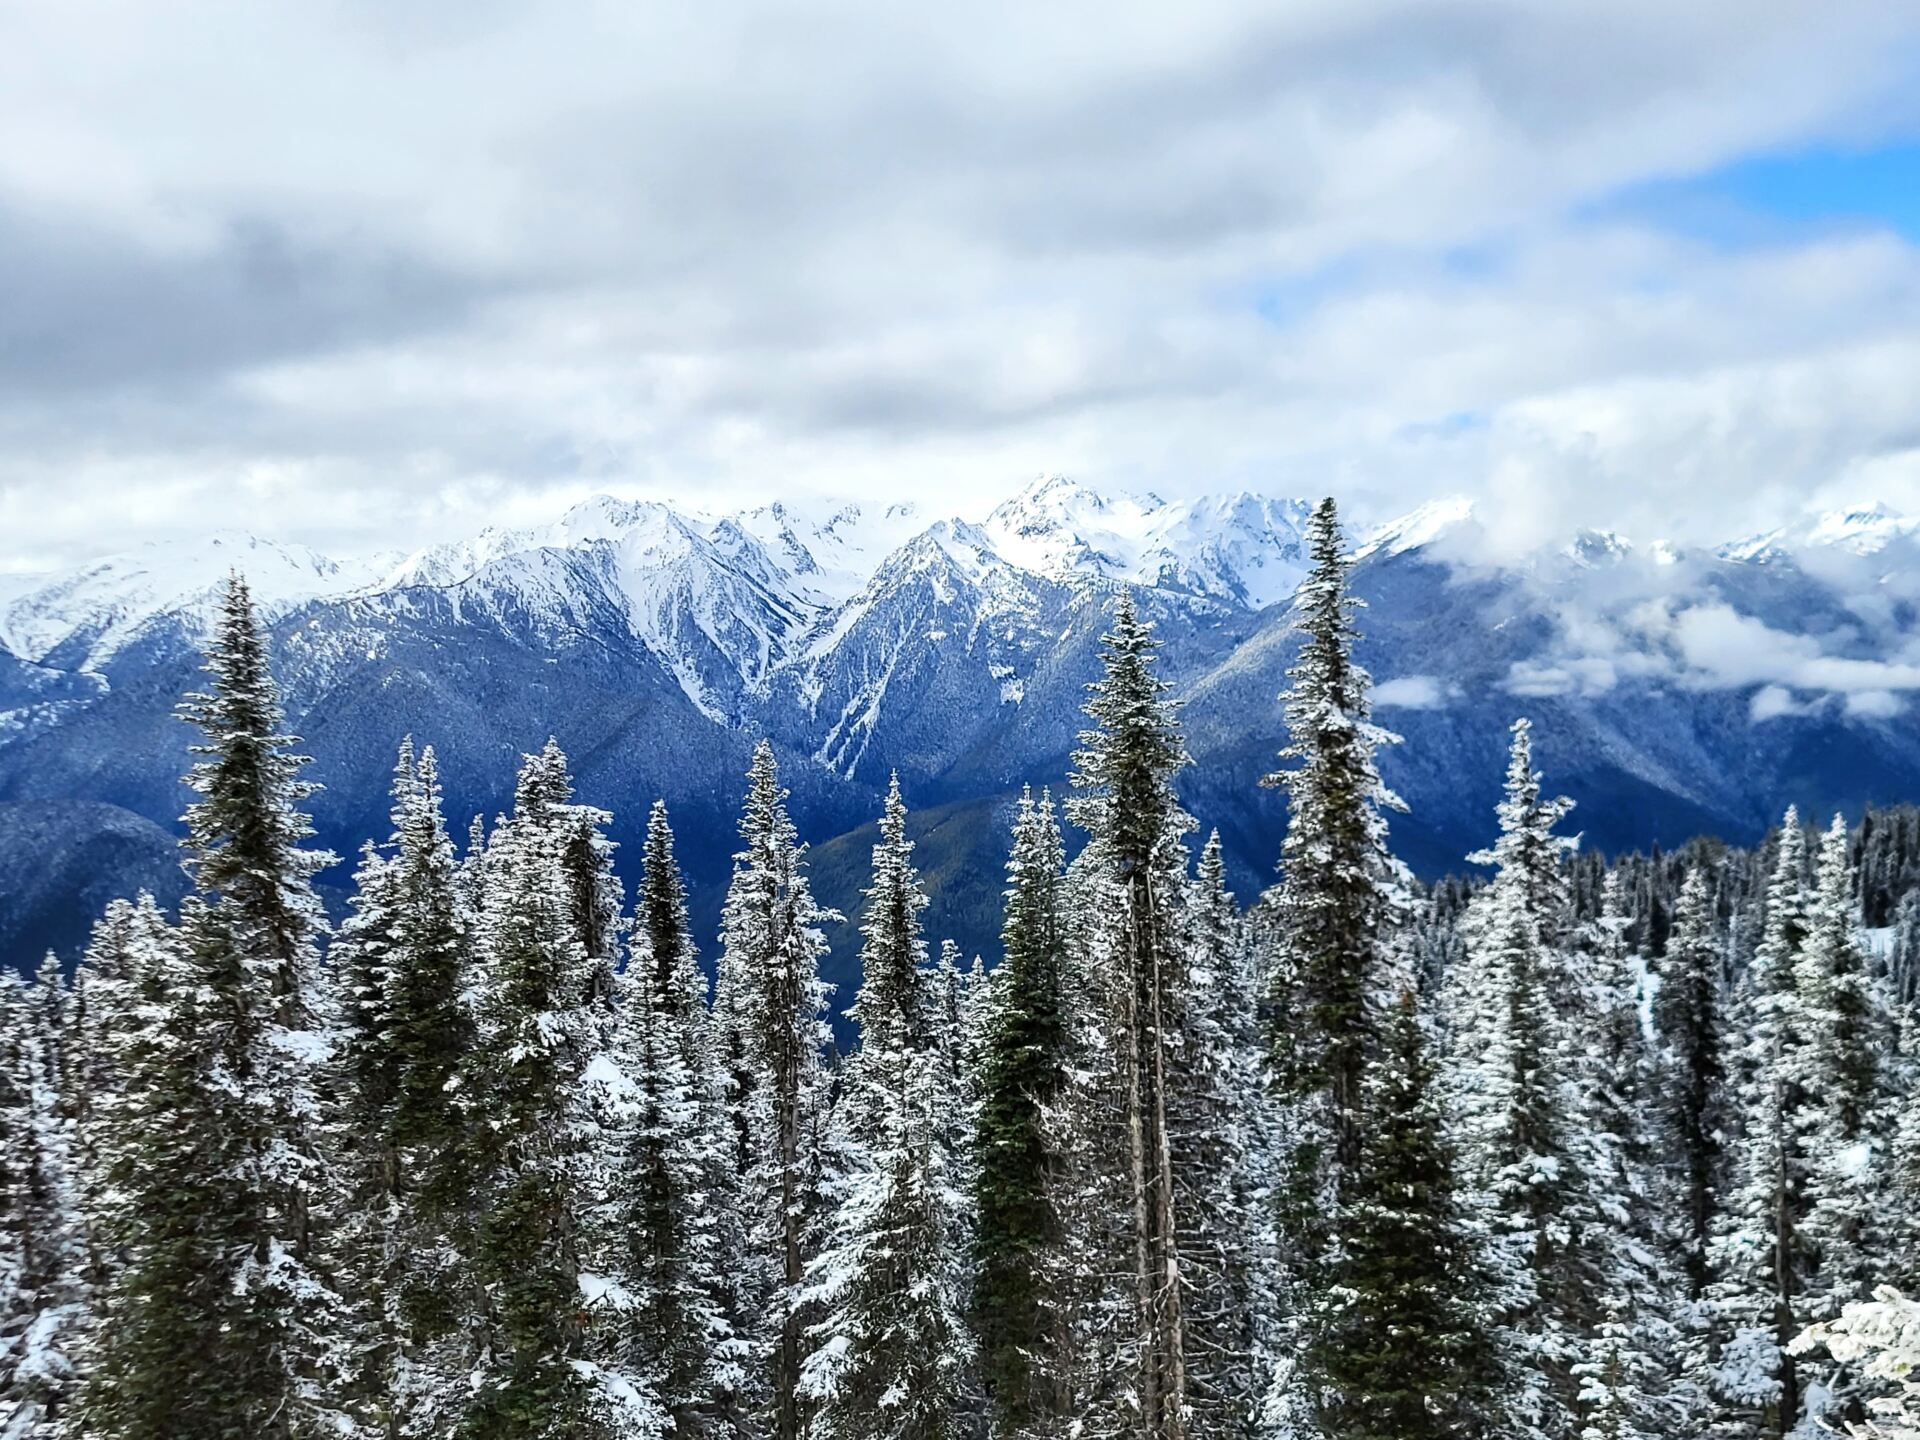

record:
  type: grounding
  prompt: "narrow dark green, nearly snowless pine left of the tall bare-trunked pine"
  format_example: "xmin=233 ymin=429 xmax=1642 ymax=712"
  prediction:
xmin=973 ymin=791 xmax=1069 ymax=1436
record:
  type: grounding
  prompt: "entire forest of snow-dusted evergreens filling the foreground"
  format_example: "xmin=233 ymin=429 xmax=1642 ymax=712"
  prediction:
xmin=0 ymin=501 xmax=1920 ymax=1440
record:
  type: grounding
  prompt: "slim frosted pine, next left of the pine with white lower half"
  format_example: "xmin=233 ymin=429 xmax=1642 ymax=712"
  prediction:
xmin=714 ymin=741 xmax=839 ymax=1440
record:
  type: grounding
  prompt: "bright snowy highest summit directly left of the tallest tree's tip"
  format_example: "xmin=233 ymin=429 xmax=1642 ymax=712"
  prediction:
xmin=985 ymin=476 xmax=1311 ymax=609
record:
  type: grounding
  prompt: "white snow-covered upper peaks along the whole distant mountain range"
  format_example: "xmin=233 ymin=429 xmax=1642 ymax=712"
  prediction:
xmin=11 ymin=476 xmax=1920 ymax=733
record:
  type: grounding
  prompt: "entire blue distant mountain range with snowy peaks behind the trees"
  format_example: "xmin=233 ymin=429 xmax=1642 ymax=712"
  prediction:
xmin=0 ymin=478 xmax=1920 ymax=1013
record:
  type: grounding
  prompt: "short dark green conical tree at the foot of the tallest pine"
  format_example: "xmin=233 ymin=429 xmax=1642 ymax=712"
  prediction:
xmin=1302 ymin=995 xmax=1494 ymax=1440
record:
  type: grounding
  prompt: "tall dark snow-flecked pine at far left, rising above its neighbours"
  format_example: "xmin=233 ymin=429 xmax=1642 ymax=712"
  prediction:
xmin=72 ymin=576 xmax=351 ymax=1440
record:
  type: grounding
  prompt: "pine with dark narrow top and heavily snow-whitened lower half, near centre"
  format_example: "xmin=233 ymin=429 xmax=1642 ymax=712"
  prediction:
xmin=803 ymin=776 xmax=972 ymax=1440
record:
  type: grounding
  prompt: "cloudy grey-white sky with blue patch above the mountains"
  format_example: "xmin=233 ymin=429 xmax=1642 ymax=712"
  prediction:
xmin=0 ymin=0 xmax=1920 ymax=570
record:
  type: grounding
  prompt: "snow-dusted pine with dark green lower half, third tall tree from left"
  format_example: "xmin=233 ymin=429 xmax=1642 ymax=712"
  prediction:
xmin=459 ymin=745 xmax=664 ymax=1440
